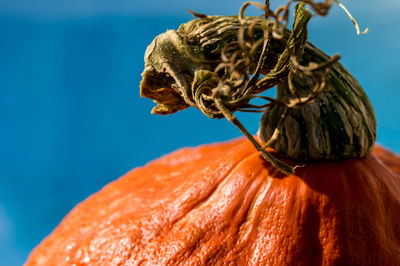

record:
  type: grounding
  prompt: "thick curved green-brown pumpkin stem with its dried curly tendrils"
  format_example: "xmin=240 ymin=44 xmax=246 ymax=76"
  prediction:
xmin=141 ymin=0 xmax=376 ymax=174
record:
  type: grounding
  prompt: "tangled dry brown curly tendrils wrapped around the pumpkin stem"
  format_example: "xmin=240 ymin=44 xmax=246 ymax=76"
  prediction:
xmin=184 ymin=0 xmax=366 ymax=174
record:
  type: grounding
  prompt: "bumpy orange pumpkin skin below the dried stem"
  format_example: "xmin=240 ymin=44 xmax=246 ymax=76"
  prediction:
xmin=26 ymin=139 xmax=400 ymax=265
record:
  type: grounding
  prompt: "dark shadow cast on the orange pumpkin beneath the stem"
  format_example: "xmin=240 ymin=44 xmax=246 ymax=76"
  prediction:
xmin=264 ymin=151 xmax=400 ymax=264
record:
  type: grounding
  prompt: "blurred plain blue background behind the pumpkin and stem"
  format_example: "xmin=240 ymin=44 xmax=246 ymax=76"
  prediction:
xmin=0 ymin=0 xmax=400 ymax=265
